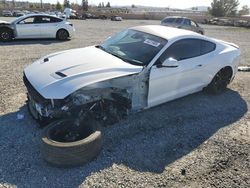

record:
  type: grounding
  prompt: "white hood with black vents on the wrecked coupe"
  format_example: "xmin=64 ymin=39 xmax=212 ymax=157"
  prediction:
xmin=24 ymin=46 xmax=143 ymax=99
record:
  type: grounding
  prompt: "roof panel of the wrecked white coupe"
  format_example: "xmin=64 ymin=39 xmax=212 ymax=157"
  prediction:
xmin=130 ymin=25 xmax=200 ymax=40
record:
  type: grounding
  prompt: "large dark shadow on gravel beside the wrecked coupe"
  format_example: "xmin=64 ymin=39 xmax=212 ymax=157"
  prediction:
xmin=0 ymin=90 xmax=248 ymax=187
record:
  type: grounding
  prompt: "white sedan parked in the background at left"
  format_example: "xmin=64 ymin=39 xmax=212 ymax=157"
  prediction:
xmin=0 ymin=14 xmax=75 ymax=41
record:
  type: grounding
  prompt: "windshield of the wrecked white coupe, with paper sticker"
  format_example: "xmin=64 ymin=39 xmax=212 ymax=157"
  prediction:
xmin=97 ymin=29 xmax=167 ymax=66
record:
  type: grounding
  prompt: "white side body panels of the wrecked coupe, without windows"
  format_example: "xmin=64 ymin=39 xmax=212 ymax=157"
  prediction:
xmin=148 ymin=36 xmax=240 ymax=108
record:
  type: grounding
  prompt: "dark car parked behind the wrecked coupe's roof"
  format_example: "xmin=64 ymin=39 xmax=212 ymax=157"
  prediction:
xmin=161 ymin=16 xmax=205 ymax=35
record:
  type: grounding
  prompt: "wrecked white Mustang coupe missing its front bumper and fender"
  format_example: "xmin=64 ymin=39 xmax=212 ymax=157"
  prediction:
xmin=24 ymin=25 xmax=240 ymax=125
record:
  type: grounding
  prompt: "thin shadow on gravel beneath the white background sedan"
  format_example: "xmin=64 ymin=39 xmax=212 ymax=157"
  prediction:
xmin=0 ymin=39 xmax=70 ymax=46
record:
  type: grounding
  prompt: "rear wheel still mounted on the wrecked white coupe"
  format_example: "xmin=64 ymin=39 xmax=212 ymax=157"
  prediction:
xmin=205 ymin=67 xmax=232 ymax=94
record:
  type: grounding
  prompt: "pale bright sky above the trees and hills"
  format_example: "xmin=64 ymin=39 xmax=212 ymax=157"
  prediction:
xmin=14 ymin=0 xmax=250 ymax=8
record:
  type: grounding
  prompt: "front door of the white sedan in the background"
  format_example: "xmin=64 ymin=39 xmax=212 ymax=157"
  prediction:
xmin=16 ymin=16 xmax=41 ymax=38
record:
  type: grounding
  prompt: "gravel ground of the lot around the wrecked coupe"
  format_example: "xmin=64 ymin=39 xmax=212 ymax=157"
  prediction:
xmin=0 ymin=18 xmax=250 ymax=188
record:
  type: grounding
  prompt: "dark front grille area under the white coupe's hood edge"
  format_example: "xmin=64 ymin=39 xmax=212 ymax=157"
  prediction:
xmin=23 ymin=74 xmax=50 ymax=104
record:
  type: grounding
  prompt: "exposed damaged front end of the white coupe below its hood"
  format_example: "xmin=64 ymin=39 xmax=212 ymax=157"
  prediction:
xmin=24 ymin=73 xmax=148 ymax=124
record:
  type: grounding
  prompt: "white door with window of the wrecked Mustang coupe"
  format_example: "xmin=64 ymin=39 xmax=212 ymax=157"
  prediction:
xmin=148 ymin=39 xmax=209 ymax=107
